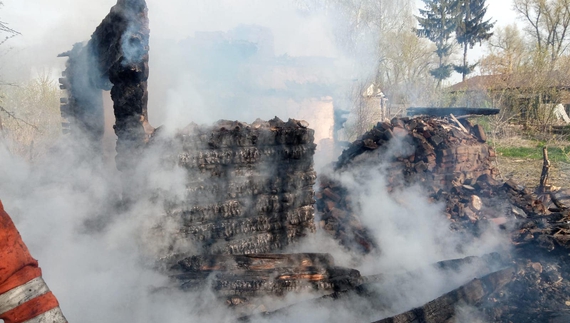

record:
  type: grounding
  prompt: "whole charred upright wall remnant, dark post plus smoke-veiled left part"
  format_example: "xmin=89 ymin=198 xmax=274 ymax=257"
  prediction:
xmin=60 ymin=0 xmax=154 ymax=170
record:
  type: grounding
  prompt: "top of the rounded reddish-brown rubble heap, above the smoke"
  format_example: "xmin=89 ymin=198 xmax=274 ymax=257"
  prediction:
xmin=336 ymin=117 xmax=498 ymax=188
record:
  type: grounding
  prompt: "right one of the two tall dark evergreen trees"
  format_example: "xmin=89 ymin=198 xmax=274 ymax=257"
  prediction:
xmin=454 ymin=0 xmax=494 ymax=81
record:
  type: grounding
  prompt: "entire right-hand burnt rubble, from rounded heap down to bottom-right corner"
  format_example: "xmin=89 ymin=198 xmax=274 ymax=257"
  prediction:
xmin=317 ymin=117 xmax=570 ymax=322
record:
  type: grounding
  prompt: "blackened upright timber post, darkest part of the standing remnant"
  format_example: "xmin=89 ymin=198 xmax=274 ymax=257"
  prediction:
xmin=93 ymin=0 xmax=153 ymax=170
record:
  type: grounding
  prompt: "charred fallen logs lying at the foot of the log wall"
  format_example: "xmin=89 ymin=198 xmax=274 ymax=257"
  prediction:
xmin=171 ymin=254 xmax=362 ymax=306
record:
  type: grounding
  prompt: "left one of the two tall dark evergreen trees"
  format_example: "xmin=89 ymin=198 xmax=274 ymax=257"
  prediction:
xmin=416 ymin=0 xmax=459 ymax=87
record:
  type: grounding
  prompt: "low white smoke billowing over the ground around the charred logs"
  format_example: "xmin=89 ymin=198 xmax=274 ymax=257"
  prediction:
xmin=0 ymin=135 xmax=508 ymax=322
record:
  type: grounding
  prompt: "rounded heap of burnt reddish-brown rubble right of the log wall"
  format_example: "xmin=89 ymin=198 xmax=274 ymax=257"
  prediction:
xmin=317 ymin=117 xmax=498 ymax=253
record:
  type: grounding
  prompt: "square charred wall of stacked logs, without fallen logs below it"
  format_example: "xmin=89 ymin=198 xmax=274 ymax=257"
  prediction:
xmin=159 ymin=118 xmax=316 ymax=255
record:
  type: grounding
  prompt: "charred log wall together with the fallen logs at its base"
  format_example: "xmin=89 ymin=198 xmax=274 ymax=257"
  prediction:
xmin=151 ymin=118 xmax=372 ymax=313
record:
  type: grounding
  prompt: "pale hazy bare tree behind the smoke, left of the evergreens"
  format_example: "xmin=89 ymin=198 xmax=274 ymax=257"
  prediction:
xmin=297 ymin=0 xmax=424 ymax=139
